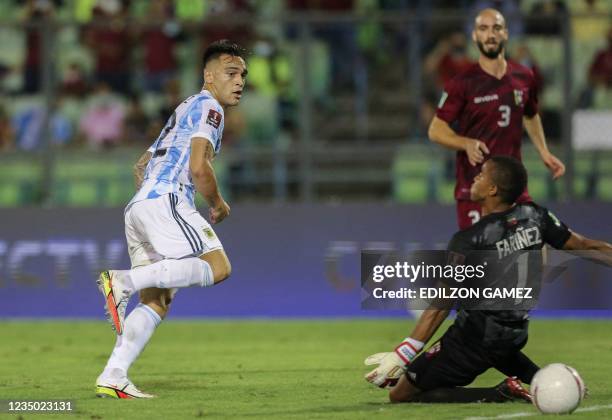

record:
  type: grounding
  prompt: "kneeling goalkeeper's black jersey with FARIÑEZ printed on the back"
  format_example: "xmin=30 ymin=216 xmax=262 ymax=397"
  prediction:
xmin=448 ymin=203 xmax=571 ymax=341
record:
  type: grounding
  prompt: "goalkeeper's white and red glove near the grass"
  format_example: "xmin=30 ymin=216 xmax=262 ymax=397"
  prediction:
xmin=364 ymin=338 xmax=424 ymax=388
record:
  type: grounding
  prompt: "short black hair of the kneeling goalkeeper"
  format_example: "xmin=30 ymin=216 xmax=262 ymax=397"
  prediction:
xmin=489 ymin=156 xmax=527 ymax=204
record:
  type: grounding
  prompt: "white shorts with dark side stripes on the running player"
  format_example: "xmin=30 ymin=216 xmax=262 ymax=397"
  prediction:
xmin=125 ymin=194 xmax=223 ymax=268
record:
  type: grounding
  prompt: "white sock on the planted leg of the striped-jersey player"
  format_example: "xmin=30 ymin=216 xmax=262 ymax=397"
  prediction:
xmin=101 ymin=303 xmax=162 ymax=379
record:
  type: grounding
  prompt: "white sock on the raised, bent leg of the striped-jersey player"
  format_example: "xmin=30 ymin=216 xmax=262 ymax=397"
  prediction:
xmin=129 ymin=257 xmax=214 ymax=291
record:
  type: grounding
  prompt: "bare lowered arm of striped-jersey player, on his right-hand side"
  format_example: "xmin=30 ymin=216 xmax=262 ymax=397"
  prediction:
xmin=189 ymin=137 xmax=230 ymax=223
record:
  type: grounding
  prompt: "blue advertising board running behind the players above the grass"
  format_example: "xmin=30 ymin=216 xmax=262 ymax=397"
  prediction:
xmin=0 ymin=203 xmax=612 ymax=318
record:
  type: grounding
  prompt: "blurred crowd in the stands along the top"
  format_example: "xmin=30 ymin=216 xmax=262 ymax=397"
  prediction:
xmin=0 ymin=0 xmax=612 ymax=151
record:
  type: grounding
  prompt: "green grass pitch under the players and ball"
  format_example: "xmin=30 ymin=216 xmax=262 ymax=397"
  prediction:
xmin=0 ymin=319 xmax=612 ymax=420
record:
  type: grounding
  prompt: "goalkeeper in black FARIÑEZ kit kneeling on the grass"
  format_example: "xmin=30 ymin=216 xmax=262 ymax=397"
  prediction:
xmin=365 ymin=156 xmax=612 ymax=403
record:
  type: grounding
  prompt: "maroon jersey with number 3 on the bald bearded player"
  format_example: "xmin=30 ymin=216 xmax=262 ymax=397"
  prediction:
xmin=436 ymin=60 xmax=538 ymax=200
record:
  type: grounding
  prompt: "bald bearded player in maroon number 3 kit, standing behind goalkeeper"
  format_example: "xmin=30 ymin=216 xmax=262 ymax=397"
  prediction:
xmin=428 ymin=9 xmax=565 ymax=229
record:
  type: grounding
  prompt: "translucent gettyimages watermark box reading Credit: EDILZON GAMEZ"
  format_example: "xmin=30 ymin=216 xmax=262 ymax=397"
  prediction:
xmin=361 ymin=250 xmax=612 ymax=310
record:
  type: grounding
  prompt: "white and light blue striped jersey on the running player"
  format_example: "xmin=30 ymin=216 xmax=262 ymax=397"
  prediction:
xmin=128 ymin=90 xmax=224 ymax=207
